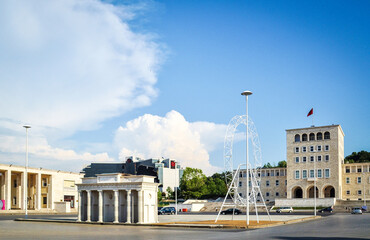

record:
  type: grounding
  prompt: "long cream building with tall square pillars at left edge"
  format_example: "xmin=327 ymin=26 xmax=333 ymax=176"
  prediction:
xmin=0 ymin=164 xmax=83 ymax=212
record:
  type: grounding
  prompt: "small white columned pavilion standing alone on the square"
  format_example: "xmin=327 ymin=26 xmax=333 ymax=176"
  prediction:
xmin=77 ymin=173 xmax=158 ymax=223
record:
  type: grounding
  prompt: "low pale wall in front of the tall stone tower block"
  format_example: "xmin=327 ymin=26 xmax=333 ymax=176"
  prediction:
xmin=275 ymin=198 xmax=336 ymax=207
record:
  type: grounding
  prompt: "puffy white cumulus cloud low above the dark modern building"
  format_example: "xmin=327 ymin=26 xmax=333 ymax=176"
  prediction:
xmin=115 ymin=111 xmax=226 ymax=174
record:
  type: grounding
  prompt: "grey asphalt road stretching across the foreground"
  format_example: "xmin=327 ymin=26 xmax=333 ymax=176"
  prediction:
xmin=0 ymin=213 xmax=370 ymax=240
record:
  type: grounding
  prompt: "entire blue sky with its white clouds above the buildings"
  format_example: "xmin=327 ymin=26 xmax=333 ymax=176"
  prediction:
xmin=0 ymin=0 xmax=370 ymax=174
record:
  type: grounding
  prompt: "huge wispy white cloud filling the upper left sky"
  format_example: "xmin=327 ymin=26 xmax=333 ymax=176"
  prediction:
xmin=0 ymin=0 xmax=162 ymax=170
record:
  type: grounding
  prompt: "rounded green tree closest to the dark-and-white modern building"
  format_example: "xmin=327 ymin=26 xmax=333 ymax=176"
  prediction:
xmin=180 ymin=167 xmax=207 ymax=199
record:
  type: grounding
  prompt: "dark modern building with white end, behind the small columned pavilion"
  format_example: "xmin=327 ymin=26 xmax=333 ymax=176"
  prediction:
xmin=81 ymin=156 xmax=183 ymax=192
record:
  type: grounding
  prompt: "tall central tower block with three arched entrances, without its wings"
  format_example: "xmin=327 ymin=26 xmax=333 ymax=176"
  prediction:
xmin=286 ymin=125 xmax=344 ymax=199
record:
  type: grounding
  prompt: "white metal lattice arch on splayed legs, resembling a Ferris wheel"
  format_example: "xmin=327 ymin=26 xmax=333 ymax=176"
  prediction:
xmin=216 ymin=115 xmax=271 ymax=222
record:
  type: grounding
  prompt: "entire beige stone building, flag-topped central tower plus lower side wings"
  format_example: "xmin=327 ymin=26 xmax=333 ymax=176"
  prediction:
xmin=238 ymin=125 xmax=370 ymax=206
